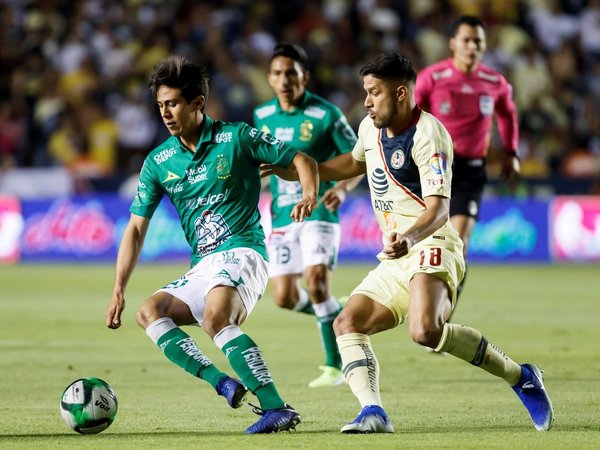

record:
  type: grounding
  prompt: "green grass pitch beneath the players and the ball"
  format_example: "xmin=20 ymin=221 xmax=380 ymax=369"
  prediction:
xmin=0 ymin=264 xmax=600 ymax=449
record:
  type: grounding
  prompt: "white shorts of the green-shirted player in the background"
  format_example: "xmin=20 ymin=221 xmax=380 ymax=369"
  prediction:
xmin=268 ymin=220 xmax=340 ymax=277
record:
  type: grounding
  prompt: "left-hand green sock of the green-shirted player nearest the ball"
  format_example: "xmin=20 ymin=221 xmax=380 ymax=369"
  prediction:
xmin=157 ymin=328 xmax=227 ymax=388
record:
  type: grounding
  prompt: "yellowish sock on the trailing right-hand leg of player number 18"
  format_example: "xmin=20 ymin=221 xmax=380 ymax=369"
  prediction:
xmin=435 ymin=323 xmax=521 ymax=386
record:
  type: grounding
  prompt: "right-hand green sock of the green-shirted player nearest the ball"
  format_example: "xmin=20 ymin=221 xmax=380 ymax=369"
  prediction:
xmin=221 ymin=334 xmax=285 ymax=409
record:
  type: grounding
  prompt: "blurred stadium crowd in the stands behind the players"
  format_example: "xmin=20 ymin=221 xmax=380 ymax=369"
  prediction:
xmin=0 ymin=0 xmax=600 ymax=193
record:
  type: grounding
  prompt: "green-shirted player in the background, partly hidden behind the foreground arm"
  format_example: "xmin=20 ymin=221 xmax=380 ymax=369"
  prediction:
xmin=254 ymin=43 xmax=361 ymax=387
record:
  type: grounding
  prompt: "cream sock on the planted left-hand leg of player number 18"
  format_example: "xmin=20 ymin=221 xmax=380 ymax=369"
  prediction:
xmin=337 ymin=333 xmax=382 ymax=408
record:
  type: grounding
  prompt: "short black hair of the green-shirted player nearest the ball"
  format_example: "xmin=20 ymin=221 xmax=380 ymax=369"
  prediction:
xmin=148 ymin=55 xmax=208 ymax=104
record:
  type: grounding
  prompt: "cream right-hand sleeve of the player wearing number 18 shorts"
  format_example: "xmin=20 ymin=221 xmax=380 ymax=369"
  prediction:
xmin=412 ymin=116 xmax=454 ymax=198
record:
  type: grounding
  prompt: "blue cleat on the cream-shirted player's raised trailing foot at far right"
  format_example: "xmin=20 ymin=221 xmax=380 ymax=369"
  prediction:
xmin=513 ymin=364 xmax=554 ymax=431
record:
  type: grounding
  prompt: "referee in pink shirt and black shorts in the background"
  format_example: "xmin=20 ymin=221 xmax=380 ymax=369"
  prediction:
xmin=415 ymin=16 xmax=520 ymax=294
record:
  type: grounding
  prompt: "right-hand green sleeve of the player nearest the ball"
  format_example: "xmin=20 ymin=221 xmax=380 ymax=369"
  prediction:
xmin=239 ymin=123 xmax=298 ymax=168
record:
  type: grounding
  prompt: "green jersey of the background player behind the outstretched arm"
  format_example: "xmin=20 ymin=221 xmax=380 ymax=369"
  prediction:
xmin=254 ymin=91 xmax=356 ymax=228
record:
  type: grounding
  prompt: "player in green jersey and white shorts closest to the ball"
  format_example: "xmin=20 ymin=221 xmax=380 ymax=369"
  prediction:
xmin=106 ymin=56 xmax=318 ymax=434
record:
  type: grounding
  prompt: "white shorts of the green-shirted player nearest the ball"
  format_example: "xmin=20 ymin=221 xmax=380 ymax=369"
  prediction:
xmin=156 ymin=248 xmax=268 ymax=326
